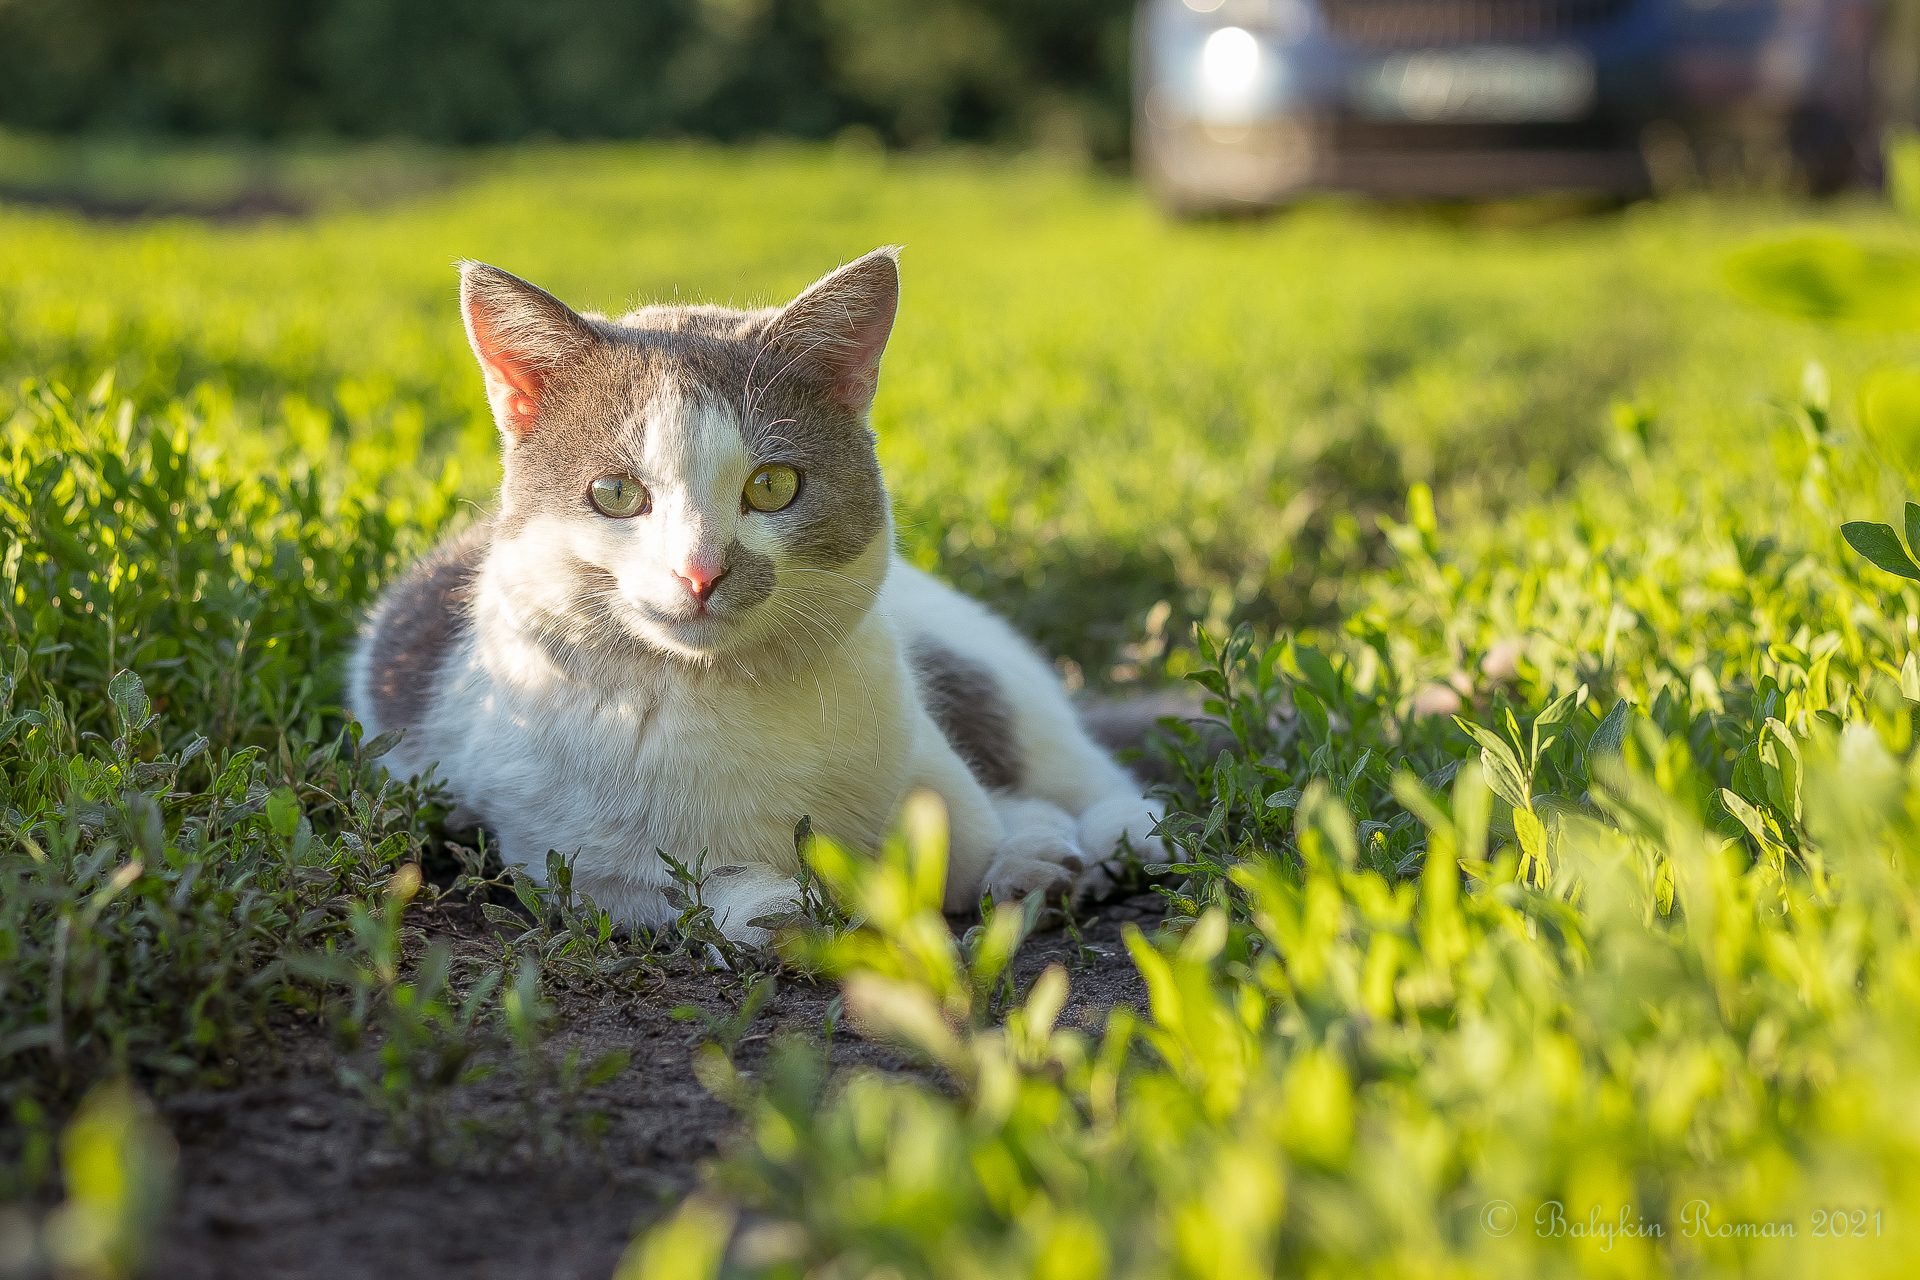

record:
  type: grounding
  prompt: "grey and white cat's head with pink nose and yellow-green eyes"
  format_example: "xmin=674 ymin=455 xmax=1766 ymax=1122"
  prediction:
xmin=461 ymin=248 xmax=900 ymax=662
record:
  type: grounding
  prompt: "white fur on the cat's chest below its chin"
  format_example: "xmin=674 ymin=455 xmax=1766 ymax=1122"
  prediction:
xmin=396 ymin=572 xmax=914 ymax=923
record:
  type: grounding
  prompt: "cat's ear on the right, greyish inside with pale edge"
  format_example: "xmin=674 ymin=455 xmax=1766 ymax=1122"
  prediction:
xmin=768 ymin=244 xmax=900 ymax=413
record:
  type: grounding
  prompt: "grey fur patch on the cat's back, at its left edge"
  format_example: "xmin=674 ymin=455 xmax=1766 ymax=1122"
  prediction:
xmin=367 ymin=520 xmax=493 ymax=729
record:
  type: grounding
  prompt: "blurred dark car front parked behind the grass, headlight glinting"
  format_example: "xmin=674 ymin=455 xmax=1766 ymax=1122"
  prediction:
xmin=1135 ymin=0 xmax=1874 ymax=213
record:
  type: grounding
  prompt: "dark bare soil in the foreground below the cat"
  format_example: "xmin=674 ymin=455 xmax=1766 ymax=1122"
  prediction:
xmin=150 ymin=894 xmax=1162 ymax=1280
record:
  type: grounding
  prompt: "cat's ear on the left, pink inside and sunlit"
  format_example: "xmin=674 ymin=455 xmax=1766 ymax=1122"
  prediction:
xmin=461 ymin=261 xmax=599 ymax=441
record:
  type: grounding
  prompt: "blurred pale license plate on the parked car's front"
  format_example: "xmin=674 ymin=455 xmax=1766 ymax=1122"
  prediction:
xmin=1354 ymin=48 xmax=1594 ymax=123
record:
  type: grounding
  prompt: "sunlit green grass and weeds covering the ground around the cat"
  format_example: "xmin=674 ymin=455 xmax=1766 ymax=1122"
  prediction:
xmin=0 ymin=138 xmax=1920 ymax=1278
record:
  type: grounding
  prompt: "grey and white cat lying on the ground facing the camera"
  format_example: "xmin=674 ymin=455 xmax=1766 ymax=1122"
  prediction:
xmin=349 ymin=248 xmax=1165 ymax=944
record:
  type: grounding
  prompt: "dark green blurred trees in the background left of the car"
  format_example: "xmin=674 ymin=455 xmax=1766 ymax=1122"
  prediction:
xmin=0 ymin=0 xmax=1131 ymax=157
